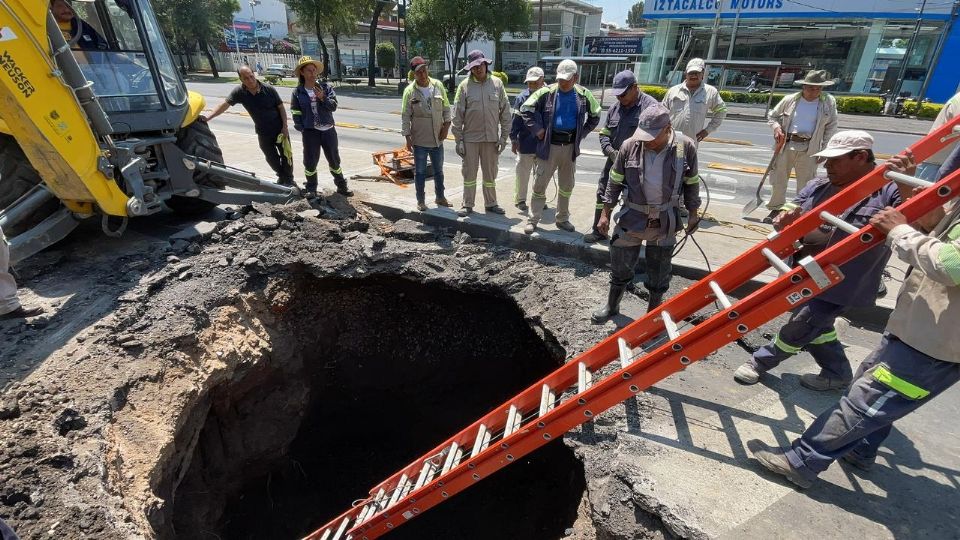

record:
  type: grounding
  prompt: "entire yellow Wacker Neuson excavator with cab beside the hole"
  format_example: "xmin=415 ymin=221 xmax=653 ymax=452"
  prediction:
xmin=0 ymin=0 xmax=298 ymax=262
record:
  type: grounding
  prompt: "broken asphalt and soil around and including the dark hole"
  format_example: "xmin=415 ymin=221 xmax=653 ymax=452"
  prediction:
xmin=0 ymin=196 xmax=684 ymax=539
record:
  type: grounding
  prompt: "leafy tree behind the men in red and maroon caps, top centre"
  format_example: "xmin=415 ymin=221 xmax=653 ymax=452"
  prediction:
xmin=407 ymin=0 xmax=532 ymax=83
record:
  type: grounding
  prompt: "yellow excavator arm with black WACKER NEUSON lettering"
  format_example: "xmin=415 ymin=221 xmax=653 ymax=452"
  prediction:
xmin=0 ymin=0 xmax=130 ymax=216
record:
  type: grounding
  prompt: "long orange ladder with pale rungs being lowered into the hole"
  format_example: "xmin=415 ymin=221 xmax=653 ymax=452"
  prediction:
xmin=306 ymin=117 xmax=960 ymax=540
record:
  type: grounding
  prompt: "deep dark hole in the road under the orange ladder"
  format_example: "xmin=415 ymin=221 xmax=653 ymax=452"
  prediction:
xmin=165 ymin=275 xmax=585 ymax=539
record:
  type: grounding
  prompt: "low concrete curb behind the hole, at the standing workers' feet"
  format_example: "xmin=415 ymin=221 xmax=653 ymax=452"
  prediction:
xmin=363 ymin=195 xmax=893 ymax=329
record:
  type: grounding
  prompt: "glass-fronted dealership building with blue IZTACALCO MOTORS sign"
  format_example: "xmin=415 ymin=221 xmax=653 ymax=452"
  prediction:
xmin=638 ymin=0 xmax=960 ymax=103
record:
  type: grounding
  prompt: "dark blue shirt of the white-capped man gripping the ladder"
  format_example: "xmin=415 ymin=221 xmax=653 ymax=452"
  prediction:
xmin=793 ymin=177 xmax=901 ymax=307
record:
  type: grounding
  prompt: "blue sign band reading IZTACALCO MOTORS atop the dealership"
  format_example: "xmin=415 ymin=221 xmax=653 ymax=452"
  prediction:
xmin=643 ymin=0 xmax=952 ymax=19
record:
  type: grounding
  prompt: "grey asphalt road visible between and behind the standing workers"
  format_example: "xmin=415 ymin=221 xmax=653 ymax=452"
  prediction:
xmin=188 ymin=82 xmax=917 ymax=210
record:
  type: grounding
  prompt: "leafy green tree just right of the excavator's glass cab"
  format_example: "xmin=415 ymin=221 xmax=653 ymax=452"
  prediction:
xmin=153 ymin=0 xmax=240 ymax=77
